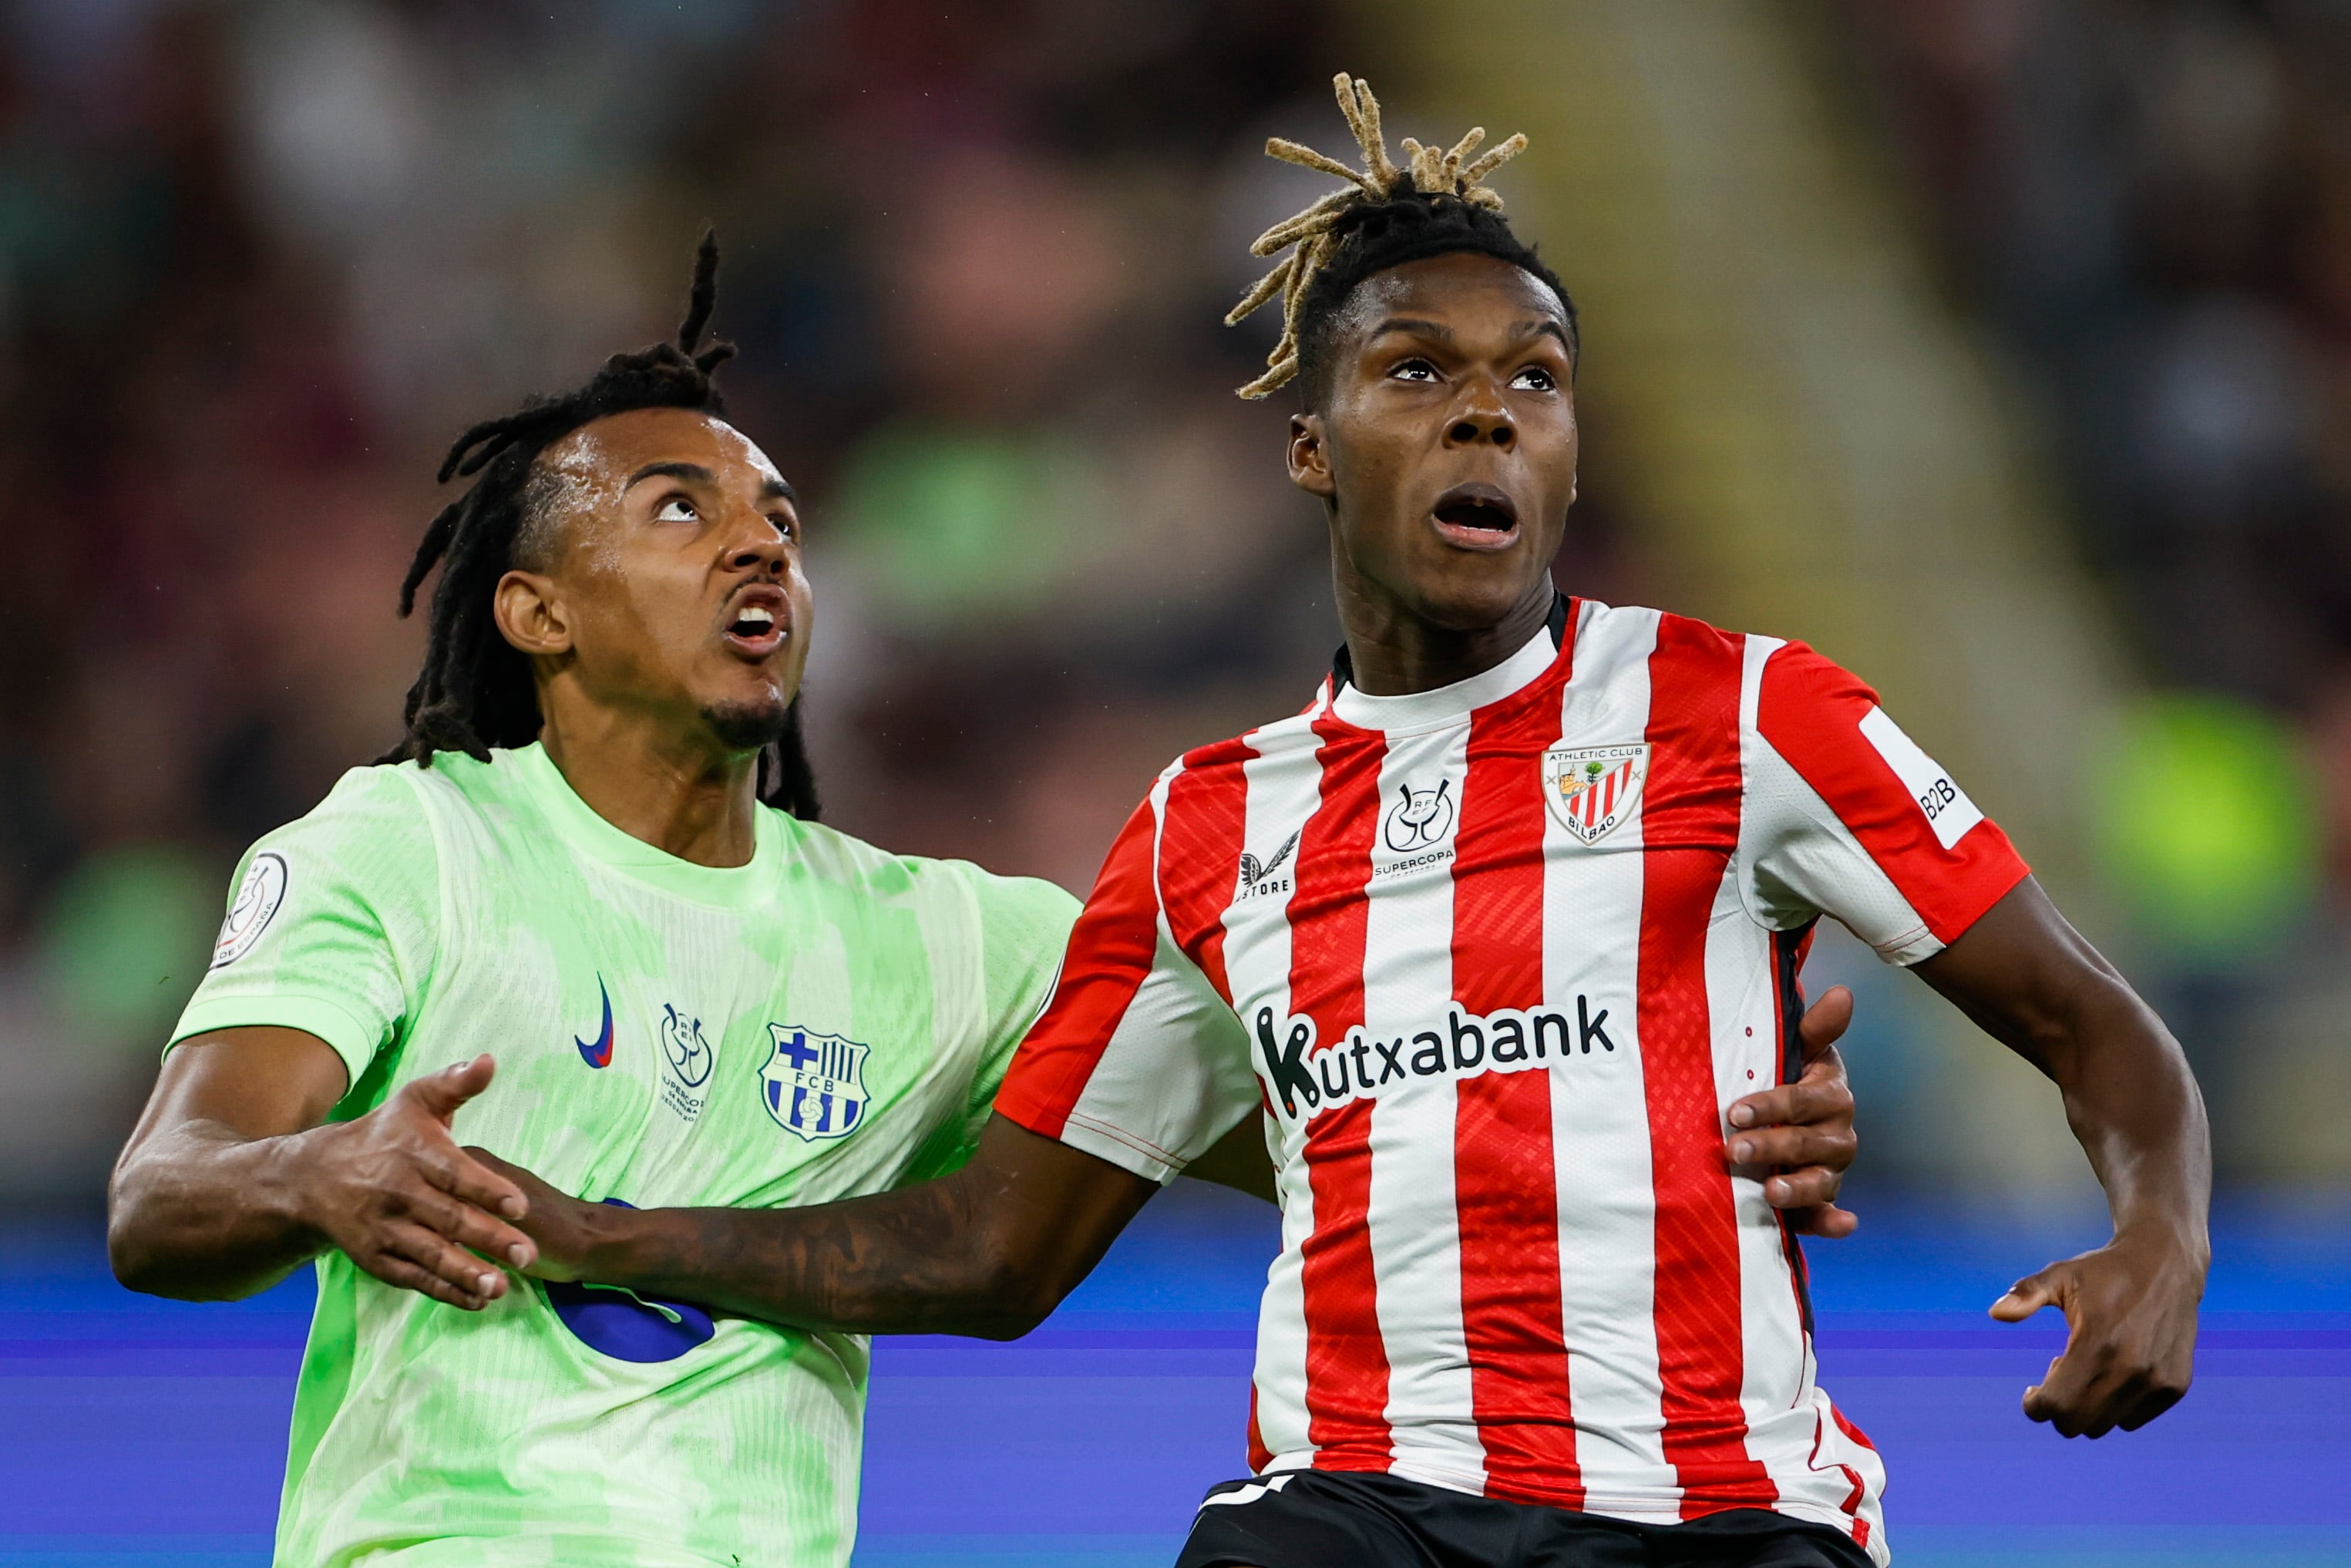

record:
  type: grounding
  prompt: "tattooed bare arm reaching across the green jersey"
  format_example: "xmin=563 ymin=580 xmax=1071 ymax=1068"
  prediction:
xmin=468 ymin=1117 xmax=1159 ymax=1340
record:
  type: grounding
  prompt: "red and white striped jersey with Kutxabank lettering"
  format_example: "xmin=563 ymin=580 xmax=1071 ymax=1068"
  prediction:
xmin=997 ymin=600 xmax=2024 ymax=1561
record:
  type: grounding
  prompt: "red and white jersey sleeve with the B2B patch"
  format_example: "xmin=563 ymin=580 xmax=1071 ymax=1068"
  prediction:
xmin=1740 ymin=642 xmax=2026 ymax=964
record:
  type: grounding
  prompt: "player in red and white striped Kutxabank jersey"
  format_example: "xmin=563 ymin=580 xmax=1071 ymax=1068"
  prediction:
xmin=477 ymin=76 xmax=2210 ymax=1568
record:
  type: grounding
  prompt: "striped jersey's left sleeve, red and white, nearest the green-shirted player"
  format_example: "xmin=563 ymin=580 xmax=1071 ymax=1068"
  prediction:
xmin=997 ymin=802 xmax=1258 ymax=1183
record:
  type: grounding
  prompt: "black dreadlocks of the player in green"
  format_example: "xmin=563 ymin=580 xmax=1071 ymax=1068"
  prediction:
xmin=378 ymin=230 xmax=818 ymax=823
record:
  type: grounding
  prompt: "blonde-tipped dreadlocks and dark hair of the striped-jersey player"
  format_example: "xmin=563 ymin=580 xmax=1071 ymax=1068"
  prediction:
xmin=1225 ymin=70 xmax=1576 ymax=405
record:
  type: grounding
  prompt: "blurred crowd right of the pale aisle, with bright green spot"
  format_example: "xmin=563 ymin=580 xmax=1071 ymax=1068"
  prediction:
xmin=1838 ymin=0 xmax=2351 ymax=1192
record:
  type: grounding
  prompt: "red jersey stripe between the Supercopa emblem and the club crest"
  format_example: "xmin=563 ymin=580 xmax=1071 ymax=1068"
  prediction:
xmin=1453 ymin=677 xmax=1585 ymax=1509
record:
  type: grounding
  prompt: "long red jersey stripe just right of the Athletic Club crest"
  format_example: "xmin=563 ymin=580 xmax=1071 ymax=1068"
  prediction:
xmin=1639 ymin=616 xmax=1780 ymax=1519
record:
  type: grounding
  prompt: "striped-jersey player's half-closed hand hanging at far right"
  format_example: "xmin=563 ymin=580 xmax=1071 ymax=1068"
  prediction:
xmin=1991 ymin=1239 xmax=2205 ymax=1436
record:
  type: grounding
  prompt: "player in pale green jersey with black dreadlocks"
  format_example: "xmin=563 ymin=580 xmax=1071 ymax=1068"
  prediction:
xmin=108 ymin=242 xmax=1850 ymax=1568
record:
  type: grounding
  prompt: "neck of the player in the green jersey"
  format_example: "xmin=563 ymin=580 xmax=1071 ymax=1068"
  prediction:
xmin=538 ymin=708 xmax=759 ymax=867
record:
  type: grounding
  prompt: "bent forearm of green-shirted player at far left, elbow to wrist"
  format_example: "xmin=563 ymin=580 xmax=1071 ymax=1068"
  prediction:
xmin=106 ymin=1122 xmax=325 ymax=1300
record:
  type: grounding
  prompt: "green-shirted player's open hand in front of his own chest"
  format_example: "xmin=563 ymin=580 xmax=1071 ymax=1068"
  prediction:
xmin=298 ymin=1055 xmax=536 ymax=1312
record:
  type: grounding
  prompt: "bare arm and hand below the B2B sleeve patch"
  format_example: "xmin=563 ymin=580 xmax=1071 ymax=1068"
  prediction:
xmin=1919 ymin=880 xmax=2212 ymax=1436
